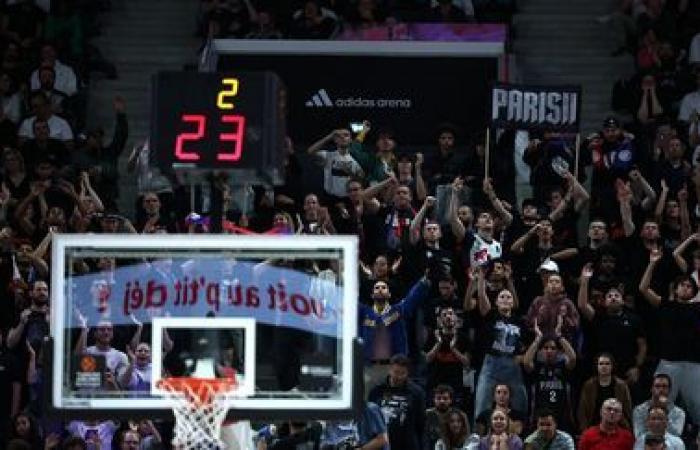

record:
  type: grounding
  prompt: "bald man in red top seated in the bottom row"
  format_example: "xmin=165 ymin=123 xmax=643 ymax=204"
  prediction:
xmin=579 ymin=398 xmax=634 ymax=450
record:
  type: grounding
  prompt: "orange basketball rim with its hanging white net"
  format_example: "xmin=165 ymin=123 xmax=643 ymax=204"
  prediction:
xmin=157 ymin=377 xmax=237 ymax=450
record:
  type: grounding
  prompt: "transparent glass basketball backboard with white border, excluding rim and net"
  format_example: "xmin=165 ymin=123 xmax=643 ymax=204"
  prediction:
xmin=51 ymin=235 xmax=358 ymax=413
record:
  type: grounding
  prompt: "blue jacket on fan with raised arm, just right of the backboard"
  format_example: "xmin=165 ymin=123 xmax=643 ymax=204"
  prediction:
xmin=358 ymin=279 xmax=429 ymax=361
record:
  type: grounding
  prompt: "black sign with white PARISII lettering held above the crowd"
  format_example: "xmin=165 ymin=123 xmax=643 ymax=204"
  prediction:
xmin=490 ymin=83 xmax=581 ymax=132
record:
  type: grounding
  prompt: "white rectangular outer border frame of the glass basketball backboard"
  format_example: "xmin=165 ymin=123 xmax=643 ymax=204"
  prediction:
xmin=44 ymin=235 xmax=363 ymax=420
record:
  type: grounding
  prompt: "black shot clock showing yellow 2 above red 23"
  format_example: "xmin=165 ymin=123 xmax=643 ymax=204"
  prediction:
xmin=151 ymin=72 xmax=286 ymax=178
